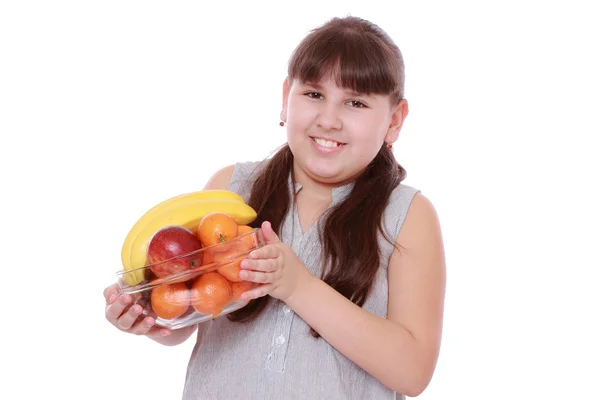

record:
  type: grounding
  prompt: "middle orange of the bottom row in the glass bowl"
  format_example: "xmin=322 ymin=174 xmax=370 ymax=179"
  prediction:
xmin=191 ymin=272 xmax=232 ymax=317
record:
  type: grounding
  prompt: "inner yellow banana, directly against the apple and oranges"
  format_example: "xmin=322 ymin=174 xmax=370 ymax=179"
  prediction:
xmin=122 ymin=200 xmax=256 ymax=284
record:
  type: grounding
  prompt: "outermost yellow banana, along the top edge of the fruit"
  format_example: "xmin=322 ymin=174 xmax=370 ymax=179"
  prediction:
xmin=121 ymin=189 xmax=245 ymax=286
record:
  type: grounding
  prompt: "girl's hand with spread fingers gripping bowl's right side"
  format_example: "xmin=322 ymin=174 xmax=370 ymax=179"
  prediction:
xmin=240 ymin=221 xmax=313 ymax=301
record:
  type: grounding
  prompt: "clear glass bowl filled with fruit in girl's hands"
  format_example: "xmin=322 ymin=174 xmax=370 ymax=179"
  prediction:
xmin=117 ymin=228 xmax=264 ymax=329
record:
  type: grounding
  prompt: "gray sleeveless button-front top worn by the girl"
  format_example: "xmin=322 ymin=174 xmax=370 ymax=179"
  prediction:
xmin=183 ymin=162 xmax=418 ymax=400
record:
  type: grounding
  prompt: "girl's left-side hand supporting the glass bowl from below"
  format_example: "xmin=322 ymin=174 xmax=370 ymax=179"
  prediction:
xmin=104 ymin=283 xmax=171 ymax=338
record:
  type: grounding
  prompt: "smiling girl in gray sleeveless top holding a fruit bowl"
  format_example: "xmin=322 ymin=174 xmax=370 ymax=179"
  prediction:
xmin=104 ymin=17 xmax=445 ymax=400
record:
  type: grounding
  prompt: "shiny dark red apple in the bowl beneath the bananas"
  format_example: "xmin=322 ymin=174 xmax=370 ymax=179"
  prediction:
xmin=146 ymin=226 xmax=202 ymax=278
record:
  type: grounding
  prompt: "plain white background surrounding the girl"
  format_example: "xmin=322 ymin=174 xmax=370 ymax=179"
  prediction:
xmin=0 ymin=0 xmax=600 ymax=400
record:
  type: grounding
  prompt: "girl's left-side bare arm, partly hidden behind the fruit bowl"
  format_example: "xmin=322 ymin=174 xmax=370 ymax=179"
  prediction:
xmin=104 ymin=165 xmax=234 ymax=346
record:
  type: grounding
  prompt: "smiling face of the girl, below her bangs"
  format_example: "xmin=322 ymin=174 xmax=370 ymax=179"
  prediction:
xmin=282 ymin=79 xmax=408 ymax=185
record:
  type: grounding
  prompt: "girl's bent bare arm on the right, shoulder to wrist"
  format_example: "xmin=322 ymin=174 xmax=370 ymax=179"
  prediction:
xmin=286 ymin=194 xmax=446 ymax=397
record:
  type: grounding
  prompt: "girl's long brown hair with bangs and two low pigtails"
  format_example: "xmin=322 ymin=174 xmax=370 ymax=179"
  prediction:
xmin=228 ymin=17 xmax=406 ymax=337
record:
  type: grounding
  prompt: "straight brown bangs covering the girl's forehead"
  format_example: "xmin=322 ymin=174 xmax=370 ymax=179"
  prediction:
xmin=288 ymin=27 xmax=404 ymax=101
